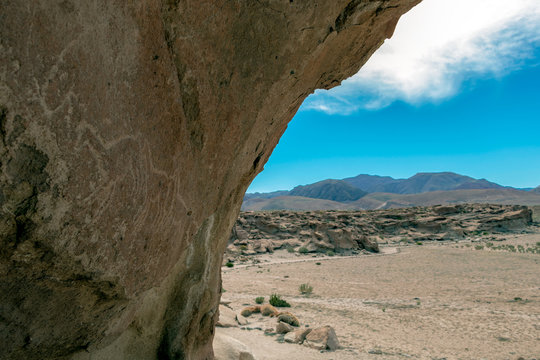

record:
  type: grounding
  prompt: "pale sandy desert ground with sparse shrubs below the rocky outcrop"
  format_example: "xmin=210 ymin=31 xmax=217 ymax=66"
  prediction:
xmin=217 ymin=233 xmax=540 ymax=360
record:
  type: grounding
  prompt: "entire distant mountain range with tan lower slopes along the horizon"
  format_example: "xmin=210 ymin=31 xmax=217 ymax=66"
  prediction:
xmin=242 ymin=172 xmax=540 ymax=211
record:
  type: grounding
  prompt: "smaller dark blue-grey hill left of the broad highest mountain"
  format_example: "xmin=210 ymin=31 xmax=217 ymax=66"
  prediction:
xmin=289 ymin=180 xmax=367 ymax=202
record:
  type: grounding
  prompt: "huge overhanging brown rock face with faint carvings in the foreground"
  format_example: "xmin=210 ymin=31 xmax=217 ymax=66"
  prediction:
xmin=0 ymin=0 xmax=420 ymax=359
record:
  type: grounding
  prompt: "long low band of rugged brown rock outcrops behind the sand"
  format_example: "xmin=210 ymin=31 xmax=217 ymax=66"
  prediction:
xmin=227 ymin=204 xmax=532 ymax=256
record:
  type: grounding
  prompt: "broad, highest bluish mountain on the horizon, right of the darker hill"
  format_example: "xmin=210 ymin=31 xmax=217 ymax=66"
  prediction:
xmin=343 ymin=172 xmax=503 ymax=194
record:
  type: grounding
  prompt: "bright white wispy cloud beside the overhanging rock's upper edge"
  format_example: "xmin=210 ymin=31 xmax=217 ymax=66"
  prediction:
xmin=303 ymin=0 xmax=540 ymax=114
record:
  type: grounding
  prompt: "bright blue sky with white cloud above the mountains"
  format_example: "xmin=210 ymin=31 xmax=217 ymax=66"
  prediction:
xmin=248 ymin=0 xmax=540 ymax=192
